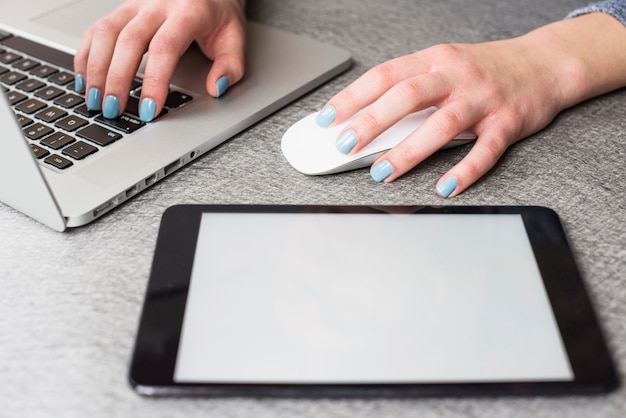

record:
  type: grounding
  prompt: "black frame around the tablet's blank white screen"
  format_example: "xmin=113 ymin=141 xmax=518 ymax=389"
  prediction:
xmin=129 ymin=205 xmax=619 ymax=397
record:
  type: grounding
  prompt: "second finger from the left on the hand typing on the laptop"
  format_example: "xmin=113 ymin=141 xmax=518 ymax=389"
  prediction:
xmin=85 ymin=12 xmax=129 ymax=110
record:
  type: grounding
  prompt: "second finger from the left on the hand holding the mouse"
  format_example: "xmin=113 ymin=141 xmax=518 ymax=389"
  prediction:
xmin=337 ymin=73 xmax=450 ymax=153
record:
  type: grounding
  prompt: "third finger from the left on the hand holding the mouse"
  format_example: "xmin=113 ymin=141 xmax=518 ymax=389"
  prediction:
xmin=370 ymin=100 xmax=480 ymax=183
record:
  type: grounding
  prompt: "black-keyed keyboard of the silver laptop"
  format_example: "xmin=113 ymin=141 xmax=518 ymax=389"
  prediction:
xmin=0 ymin=31 xmax=192 ymax=171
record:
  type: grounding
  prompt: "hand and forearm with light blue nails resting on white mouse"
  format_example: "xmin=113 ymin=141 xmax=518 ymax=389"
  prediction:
xmin=318 ymin=13 xmax=626 ymax=197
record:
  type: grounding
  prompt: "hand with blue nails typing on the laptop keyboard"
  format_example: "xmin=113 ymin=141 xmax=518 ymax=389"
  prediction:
xmin=74 ymin=0 xmax=245 ymax=122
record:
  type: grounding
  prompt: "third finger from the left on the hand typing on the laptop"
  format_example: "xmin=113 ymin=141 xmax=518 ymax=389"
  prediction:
xmin=102 ymin=13 xmax=163 ymax=118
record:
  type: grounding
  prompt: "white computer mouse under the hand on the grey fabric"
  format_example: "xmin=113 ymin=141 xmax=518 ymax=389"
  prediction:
xmin=281 ymin=107 xmax=476 ymax=175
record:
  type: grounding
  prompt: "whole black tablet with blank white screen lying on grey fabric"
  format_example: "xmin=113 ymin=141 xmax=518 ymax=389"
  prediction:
xmin=129 ymin=205 xmax=618 ymax=397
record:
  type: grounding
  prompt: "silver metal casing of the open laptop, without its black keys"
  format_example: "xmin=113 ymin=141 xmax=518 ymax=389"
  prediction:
xmin=0 ymin=0 xmax=351 ymax=231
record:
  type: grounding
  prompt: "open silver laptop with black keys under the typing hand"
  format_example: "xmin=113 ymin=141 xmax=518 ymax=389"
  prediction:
xmin=0 ymin=0 xmax=351 ymax=231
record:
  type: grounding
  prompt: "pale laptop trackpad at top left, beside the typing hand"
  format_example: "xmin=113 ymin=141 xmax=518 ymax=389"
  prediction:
xmin=32 ymin=0 xmax=123 ymax=39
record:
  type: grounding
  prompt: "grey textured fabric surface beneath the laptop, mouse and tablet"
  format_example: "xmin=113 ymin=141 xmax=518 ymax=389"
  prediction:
xmin=0 ymin=0 xmax=626 ymax=418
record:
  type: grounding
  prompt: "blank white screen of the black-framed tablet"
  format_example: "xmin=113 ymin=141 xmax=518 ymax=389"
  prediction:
xmin=174 ymin=213 xmax=573 ymax=383
